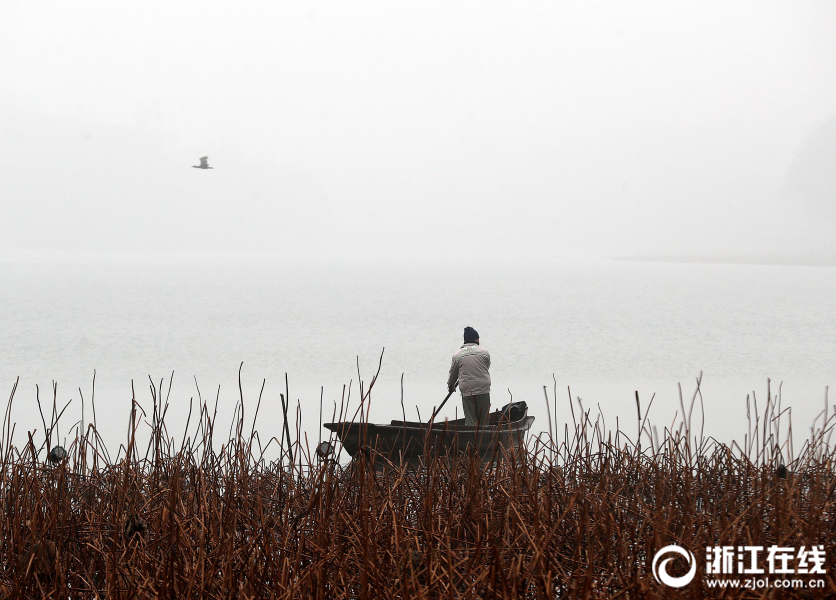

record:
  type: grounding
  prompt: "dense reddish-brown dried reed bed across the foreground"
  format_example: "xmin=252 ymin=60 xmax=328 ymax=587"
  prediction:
xmin=0 ymin=380 xmax=836 ymax=599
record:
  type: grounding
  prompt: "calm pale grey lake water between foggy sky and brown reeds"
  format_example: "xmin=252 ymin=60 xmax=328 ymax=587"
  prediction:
xmin=0 ymin=261 xmax=836 ymax=447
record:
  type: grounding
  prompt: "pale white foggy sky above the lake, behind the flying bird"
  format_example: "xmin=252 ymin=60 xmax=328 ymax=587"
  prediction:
xmin=0 ymin=1 xmax=836 ymax=260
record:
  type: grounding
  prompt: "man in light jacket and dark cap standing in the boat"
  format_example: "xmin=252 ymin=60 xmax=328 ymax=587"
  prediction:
xmin=447 ymin=327 xmax=491 ymax=427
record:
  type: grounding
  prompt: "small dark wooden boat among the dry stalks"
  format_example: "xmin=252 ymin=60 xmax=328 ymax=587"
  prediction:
xmin=325 ymin=402 xmax=534 ymax=467
